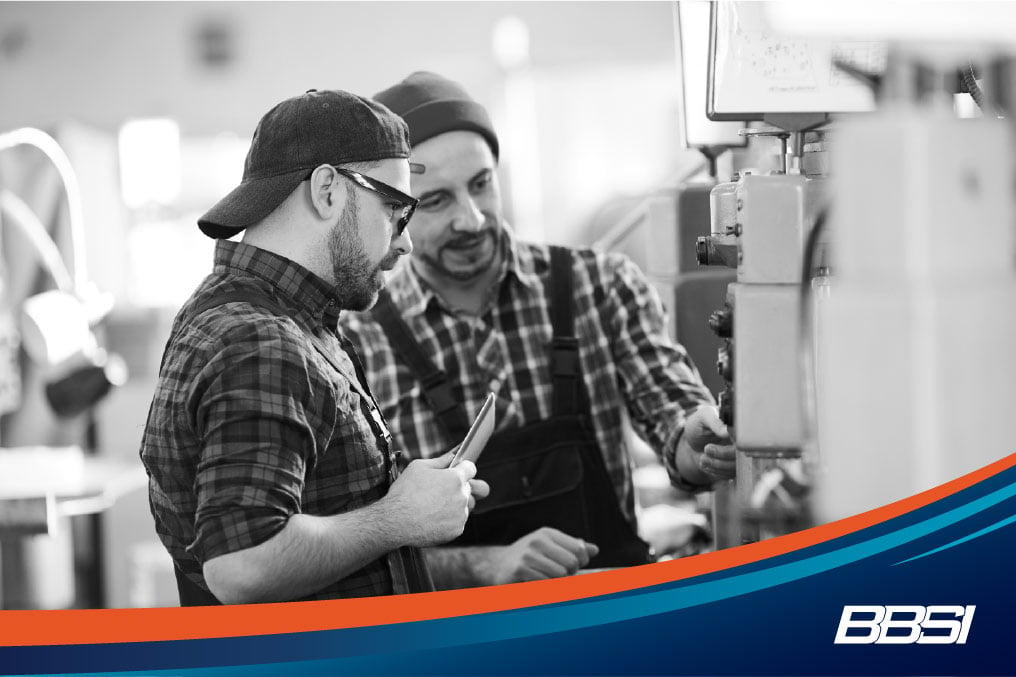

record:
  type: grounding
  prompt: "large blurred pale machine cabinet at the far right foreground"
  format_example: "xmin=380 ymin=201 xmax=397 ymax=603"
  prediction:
xmin=815 ymin=50 xmax=1016 ymax=521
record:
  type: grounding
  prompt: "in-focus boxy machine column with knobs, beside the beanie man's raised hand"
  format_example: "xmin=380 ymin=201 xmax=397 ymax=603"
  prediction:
xmin=697 ymin=121 xmax=826 ymax=547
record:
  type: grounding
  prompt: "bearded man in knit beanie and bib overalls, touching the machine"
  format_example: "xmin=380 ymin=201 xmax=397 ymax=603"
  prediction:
xmin=342 ymin=72 xmax=735 ymax=588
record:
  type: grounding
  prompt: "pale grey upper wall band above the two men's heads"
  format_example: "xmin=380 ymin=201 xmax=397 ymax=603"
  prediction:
xmin=0 ymin=2 xmax=674 ymax=135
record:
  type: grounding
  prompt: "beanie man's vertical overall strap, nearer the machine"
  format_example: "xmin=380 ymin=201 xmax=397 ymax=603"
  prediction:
xmin=549 ymin=246 xmax=581 ymax=416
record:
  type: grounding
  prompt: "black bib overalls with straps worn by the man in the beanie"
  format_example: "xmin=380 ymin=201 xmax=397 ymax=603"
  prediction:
xmin=372 ymin=247 xmax=653 ymax=568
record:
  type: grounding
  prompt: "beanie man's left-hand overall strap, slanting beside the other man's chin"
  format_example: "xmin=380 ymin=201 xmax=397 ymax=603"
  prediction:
xmin=371 ymin=290 xmax=469 ymax=437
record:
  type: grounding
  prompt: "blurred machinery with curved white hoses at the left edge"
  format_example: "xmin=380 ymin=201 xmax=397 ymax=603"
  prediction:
xmin=0 ymin=128 xmax=135 ymax=608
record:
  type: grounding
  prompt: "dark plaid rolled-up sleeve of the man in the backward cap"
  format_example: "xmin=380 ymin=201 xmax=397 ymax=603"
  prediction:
xmin=187 ymin=325 xmax=320 ymax=562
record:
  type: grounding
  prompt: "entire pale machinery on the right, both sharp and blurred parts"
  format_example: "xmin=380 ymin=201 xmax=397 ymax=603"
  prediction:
xmin=681 ymin=2 xmax=1016 ymax=548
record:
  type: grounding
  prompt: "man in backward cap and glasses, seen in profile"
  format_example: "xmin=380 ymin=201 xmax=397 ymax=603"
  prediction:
xmin=140 ymin=89 xmax=487 ymax=605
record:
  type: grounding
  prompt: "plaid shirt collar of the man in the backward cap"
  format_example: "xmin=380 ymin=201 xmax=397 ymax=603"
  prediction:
xmin=214 ymin=240 xmax=340 ymax=327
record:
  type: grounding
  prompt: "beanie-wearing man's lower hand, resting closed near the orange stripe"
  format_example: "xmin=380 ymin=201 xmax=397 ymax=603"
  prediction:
xmin=492 ymin=527 xmax=599 ymax=584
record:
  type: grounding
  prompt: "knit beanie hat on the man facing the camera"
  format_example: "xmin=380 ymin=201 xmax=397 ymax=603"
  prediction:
xmin=374 ymin=71 xmax=500 ymax=160
